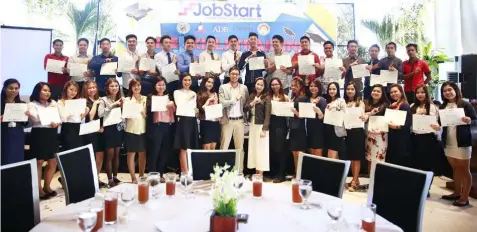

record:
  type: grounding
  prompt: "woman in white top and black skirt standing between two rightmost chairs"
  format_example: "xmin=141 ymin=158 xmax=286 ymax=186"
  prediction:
xmin=344 ymin=81 xmax=367 ymax=192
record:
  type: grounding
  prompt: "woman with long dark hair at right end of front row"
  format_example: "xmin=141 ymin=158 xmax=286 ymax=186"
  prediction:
xmin=439 ymin=81 xmax=477 ymax=207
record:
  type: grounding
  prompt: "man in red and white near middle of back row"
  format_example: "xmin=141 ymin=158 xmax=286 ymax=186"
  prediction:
xmin=292 ymin=36 xmax=322 ymax=85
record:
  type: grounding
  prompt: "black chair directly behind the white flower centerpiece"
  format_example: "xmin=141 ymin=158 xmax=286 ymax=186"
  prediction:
xmin=187 ymin=149 xmax=241 ymax=180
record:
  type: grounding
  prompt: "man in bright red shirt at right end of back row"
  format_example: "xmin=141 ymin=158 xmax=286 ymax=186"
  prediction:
xmin=402 ymin=44 xmax=432 ymax=103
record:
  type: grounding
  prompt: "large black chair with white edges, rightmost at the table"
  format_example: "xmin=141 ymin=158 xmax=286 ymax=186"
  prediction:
xmin=368 ymin=161 xmax=433 ymax=231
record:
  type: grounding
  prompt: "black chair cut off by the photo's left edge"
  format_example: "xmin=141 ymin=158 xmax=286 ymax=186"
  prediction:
xmin=0 ymin=159 xmax=40 ymax=232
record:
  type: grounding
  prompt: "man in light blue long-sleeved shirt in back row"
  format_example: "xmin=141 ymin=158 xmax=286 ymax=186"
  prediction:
xmin=177 ymin=35 xmax=201 ymax=92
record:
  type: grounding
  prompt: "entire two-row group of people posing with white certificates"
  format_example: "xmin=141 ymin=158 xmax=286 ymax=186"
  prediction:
xmin=1 ymin=32 xmax=477 ymax=206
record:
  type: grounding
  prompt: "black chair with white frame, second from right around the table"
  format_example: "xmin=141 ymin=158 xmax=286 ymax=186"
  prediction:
xmin=296 ymin=152 xmax=351 ymax=198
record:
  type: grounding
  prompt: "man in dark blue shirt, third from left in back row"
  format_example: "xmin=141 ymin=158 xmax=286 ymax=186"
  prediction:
xmin=88 ymin=38 xmax=122 ymax=97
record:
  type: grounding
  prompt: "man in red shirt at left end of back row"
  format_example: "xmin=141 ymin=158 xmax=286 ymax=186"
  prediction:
xmin=43 ymin=39 xmax=69 ymax=100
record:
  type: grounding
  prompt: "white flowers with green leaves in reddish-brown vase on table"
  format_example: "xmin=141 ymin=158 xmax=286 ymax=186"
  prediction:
xmin=210 ymin=164 xmax=240 ymax=232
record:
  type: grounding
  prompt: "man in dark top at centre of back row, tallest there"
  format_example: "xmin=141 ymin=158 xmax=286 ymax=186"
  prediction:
xmin=238 ymin=32 xmax=267 ymax=93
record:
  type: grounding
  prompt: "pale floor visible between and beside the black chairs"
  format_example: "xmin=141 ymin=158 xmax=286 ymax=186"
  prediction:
xmin=40 ymin=173 xmax=477 ymax=232
